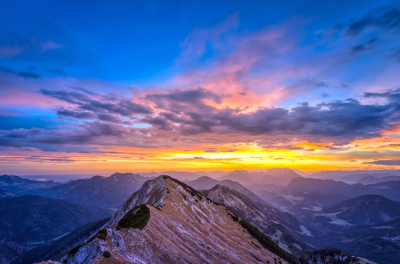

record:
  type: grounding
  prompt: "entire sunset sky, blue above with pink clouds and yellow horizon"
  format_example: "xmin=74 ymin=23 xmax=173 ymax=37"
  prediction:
xmin=0 ymin=0 xmax=400 ymax=175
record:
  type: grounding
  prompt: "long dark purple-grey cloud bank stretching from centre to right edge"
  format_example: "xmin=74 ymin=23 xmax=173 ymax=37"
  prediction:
xmin=142 ymin=88 xmax=400 ymax=140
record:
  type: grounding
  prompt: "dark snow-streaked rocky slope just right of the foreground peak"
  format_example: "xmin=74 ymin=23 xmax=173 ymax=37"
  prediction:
xmin=205 ymin=185 xmax=315 ymax=253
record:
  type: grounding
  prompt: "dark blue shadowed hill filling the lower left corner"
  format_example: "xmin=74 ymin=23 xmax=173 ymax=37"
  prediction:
xmin=0 ymin=195 xmax=111 ymax=263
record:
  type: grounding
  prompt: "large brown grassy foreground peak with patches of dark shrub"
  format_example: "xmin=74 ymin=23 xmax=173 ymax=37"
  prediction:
xmin=62 ymin=176 xmax=298 ymax=263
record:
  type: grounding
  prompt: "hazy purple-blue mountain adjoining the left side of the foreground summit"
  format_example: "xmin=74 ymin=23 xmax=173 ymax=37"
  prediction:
xmin=34 ymin=173 xmax=148 ymax=209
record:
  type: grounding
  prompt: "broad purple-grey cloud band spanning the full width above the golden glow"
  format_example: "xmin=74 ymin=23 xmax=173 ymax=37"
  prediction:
xmin=0 ymin=88 xmax=400 ymax=152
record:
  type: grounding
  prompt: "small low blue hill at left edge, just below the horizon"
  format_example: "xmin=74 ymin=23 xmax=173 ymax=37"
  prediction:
xmin=0 ymin=175 xmax=61 ymax=193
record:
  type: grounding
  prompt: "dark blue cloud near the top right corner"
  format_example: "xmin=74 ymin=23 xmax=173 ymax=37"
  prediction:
xmin=345 ymin=6 xmax=400 ymax=36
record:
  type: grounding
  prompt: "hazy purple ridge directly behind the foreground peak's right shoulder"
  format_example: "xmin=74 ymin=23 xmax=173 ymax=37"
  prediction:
xmin=186 ymin=176 xmax=266 ymax=203
